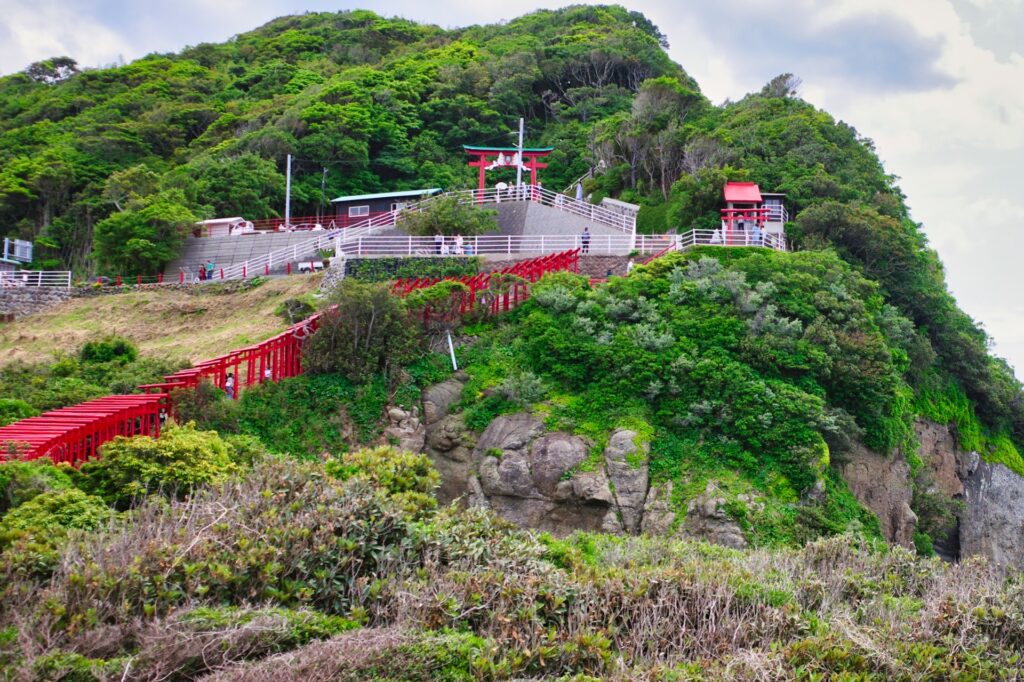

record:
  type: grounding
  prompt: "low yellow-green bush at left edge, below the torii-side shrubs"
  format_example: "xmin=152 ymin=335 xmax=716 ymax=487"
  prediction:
xmin=0 ymin=488 xmax=111 ymax=549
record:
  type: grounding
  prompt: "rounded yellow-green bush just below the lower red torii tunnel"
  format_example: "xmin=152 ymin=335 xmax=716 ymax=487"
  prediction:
xmin=80 ymin=423 xmax=239 ymax=509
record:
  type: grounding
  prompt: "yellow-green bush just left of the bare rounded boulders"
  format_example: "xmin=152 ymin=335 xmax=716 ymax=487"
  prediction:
xmin=327 ymin=445 xmax=440 ymax=516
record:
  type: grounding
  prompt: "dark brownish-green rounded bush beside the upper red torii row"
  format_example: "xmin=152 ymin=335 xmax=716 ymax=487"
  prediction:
xmin=302 ymin=279 xmax=418 ymax=383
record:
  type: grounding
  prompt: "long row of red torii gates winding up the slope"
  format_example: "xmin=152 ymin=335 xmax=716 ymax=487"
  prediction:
xmin=0 ymin=250 xmax=580 ymax=465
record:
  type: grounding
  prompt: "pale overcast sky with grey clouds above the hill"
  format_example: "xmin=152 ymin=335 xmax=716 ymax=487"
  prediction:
xmin=0 ymin=0 xmax=1024 ymax=378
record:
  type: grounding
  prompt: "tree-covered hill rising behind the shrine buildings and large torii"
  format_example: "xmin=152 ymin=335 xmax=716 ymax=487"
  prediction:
xmin=0 ymin=6 xmax=1024 ymax=472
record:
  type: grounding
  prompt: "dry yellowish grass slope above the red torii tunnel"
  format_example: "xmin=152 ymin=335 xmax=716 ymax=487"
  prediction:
xmin=0 ymin=275 xmax=321 ymax=366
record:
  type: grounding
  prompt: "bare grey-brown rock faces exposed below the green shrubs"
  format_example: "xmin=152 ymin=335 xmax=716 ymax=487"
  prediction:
xmin=417 ymin=373 xmax=1024 ymax=568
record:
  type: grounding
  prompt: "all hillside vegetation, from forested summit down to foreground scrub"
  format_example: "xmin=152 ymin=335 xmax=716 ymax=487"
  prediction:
xmin=0 ymin=6 xmax=1024 ymax=681
